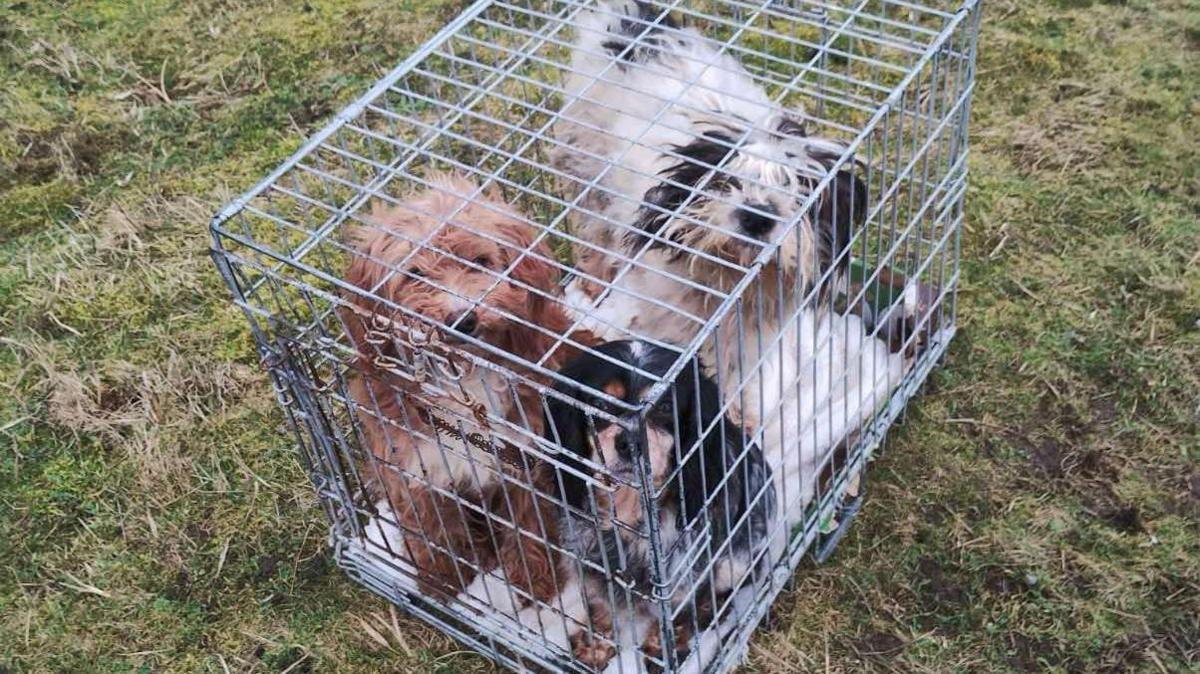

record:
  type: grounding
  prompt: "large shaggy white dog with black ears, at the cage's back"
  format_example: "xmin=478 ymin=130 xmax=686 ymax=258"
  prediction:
xmin=552 ymin=0 xmax=911 ymax=554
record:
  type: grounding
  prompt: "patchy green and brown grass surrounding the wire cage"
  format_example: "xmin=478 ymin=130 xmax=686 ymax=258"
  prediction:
xmin=0 ymin=0 xmax=1200 ymax=673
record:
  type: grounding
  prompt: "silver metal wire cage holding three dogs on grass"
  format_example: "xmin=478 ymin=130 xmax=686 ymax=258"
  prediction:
xmin=211 ymin=0 xmax=978 ymax=672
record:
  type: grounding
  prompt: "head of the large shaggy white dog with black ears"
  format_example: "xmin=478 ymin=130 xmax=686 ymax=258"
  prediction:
xmin=629 ymin=114 xmax=866 ymax=291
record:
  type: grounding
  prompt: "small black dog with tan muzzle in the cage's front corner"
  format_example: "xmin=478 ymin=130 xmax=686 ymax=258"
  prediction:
xmin=546 ymin=341 xmax=775 ymax=669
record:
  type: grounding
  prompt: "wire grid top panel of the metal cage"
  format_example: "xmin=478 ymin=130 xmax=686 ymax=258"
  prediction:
xmin=212 ymin=0 xmax=964 ymax=402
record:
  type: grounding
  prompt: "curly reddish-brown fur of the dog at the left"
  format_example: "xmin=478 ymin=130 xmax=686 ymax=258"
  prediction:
xmin=342 ymin=174 xmax=593 ymax=600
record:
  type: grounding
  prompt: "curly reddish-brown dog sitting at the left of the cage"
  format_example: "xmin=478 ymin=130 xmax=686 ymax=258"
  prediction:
xmin=341 ymin=174 xmax=592 ymax=603
